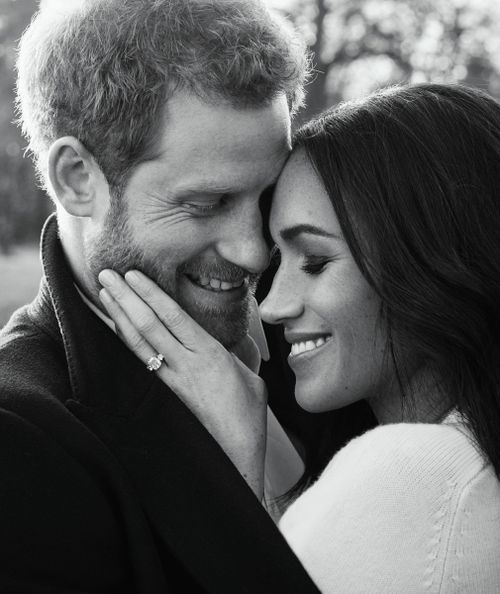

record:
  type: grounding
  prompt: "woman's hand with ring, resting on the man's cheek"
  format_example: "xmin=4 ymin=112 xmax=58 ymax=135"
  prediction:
xmin=99 ymin=270 xmax=267 ymax=499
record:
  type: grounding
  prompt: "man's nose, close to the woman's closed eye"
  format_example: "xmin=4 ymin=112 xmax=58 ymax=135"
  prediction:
xmin=217 ymin=205 xmax=270 ymax=274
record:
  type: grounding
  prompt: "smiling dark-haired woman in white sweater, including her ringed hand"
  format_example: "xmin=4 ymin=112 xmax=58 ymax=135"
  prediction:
xmin=97 ymin=84 xmax=500 ymax=594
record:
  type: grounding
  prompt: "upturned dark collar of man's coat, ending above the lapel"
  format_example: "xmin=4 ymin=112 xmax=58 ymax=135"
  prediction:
xmin=36 ymin=215 xmax=159 ymax=416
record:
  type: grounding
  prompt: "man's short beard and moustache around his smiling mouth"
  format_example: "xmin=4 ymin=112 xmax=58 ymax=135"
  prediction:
xmin=84 ymin=204 xmax=258 ymax=349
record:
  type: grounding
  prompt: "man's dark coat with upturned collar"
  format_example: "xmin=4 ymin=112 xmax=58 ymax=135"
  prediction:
xmin=0 ymin=217 xmax=317 ymax=594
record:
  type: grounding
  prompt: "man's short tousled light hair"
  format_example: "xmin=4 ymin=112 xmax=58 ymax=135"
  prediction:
xmin=17 ymin=0 xmax=309 ymax=188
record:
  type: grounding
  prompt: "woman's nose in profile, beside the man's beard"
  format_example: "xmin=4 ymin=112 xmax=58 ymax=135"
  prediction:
xmin=259 ymin=265 xmax=304 ymax=324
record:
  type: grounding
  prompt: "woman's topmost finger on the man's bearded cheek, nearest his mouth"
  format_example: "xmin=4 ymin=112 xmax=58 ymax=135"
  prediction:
xmin=125 ymin=270 xmax=211 ymax=350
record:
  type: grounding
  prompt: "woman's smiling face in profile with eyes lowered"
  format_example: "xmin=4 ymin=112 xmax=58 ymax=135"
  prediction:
xmin=261 ymin=149 xmax=388 ymax=412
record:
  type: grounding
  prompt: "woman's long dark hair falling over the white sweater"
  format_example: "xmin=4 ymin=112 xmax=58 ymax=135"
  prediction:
xmin=294 ymin=84 xmax=500 ymax=477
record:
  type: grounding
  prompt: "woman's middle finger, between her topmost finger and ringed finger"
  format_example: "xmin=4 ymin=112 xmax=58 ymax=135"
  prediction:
xmin=99 ymin=270 xmax=184 ymax=366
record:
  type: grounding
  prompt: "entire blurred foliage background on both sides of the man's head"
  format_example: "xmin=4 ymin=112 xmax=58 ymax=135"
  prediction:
xmin=0 ymin=0 xmax=500 ymax=251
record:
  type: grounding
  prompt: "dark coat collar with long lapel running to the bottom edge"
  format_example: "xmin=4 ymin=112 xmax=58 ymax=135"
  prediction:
xmin=33 ymin=216 xmax=317 ymax=594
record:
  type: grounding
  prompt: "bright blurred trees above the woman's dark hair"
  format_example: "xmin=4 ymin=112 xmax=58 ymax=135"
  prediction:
xmin=268 ymin=0 xmax=500 ymax=119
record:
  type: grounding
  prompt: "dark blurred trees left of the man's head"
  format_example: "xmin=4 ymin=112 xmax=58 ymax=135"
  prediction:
xmin=0 ymin=0 xmax=51 ymax=253
